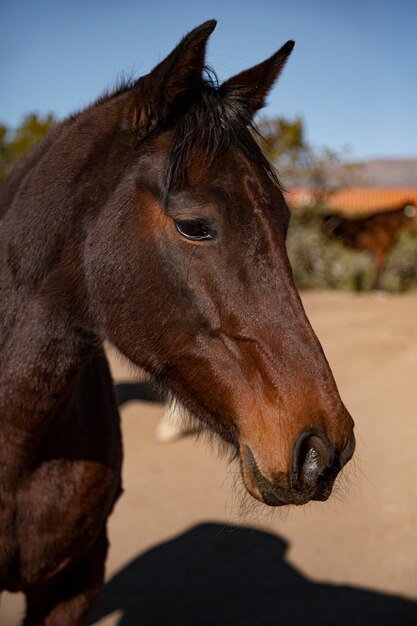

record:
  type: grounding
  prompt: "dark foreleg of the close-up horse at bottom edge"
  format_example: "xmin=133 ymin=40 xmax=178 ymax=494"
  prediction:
xmin=23 ymin=530 xmax=108 ymax=626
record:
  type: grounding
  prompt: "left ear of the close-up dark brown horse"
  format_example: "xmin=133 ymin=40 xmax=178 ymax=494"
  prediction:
xmin=133 ymin=20 xmax=217 ymax=132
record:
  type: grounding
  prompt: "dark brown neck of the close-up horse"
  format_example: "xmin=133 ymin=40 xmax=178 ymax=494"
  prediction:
xmin=0 ymin=91 xmax=132 ymax=465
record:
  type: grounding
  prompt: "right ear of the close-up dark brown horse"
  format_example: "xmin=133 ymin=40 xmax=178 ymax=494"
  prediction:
xmin=220 ymin=40 xmax=295 ymax=115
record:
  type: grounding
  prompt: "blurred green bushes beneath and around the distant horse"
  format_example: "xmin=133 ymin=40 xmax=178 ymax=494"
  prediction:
xmin=287 ymin=207 xmax=417 ymax=292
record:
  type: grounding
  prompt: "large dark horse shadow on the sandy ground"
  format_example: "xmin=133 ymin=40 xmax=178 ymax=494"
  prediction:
xmin=88 ymin=523 xmax=417 ymax=626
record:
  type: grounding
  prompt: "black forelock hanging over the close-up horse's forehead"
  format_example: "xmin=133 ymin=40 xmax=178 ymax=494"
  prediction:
xmin=163 ymin=67 xmax=280 ymax=204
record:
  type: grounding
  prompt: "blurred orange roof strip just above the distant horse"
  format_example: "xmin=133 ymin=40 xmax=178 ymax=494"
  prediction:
xmin=286 ymin=187 xmax=417 ymax=215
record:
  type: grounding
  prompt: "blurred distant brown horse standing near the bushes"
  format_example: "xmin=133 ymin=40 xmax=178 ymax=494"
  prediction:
xmin=325 ymin=202 xmax=417 ymax=289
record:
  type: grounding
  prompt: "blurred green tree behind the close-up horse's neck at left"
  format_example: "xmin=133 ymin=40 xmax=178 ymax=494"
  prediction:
xmin=0 ymin=113 xmax=56 ymax=184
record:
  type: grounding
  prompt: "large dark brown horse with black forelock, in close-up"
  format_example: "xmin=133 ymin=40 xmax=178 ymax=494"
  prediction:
xmin=0 ymin=21 xmax=354 ymax=626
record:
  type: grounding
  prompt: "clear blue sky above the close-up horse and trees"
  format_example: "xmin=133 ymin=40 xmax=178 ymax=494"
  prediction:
xmin=0 ymin=0 xmax=417 ymax=159
